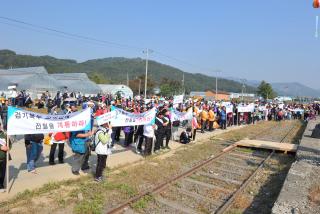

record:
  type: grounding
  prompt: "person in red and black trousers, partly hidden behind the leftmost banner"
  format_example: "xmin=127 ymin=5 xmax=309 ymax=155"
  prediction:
xmin=49 ymin=132 xmax=70 ymax=165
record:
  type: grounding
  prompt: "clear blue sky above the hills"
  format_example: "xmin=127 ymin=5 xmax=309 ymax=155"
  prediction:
xmin=0 ymin=0 xmax=320 ymax=89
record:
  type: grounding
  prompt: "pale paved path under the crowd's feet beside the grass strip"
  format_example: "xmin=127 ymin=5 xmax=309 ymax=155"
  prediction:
xmin=0 ymin=126 xmax=241 ymax=201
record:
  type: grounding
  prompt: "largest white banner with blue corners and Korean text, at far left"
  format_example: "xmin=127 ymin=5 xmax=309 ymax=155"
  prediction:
xmin=7 ymin=106 xmax=91 ymax=135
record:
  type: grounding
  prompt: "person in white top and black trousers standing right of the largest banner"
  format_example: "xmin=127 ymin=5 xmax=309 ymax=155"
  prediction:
xmin=94 ymin=122 xmax=112 ymax=182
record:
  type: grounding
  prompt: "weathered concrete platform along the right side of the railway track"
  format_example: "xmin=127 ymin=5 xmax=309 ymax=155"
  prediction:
xmin=272 ymin=117 xmax=320 ymax=214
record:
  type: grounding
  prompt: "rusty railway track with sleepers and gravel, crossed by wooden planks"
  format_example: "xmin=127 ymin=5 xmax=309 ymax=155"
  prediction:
xmin=107 ymin=123 xmax=295 ymax=214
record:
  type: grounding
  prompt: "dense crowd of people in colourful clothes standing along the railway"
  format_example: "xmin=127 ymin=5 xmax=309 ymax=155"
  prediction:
xmin=0 ymin=91 xmax=320 ymax=192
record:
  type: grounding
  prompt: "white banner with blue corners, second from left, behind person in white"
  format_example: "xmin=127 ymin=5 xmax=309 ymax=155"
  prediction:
xmin=96 ymin=107 xmax=156 ymax=127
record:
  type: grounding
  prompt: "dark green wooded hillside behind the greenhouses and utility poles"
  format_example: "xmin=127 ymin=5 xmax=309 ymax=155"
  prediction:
xmin=0 ymin=50 xmax=255 ymax=92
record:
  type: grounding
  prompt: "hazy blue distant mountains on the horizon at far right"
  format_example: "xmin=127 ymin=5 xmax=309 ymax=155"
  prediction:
xmin=227 ymin=77 xmax=320 ymax=97
